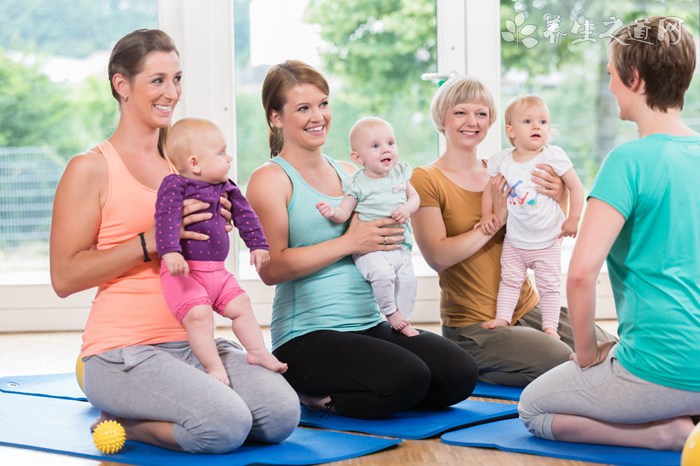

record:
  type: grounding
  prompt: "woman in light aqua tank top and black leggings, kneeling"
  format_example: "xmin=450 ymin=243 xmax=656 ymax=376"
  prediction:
xmin=246 ymin=60 xmax=477 ymax=419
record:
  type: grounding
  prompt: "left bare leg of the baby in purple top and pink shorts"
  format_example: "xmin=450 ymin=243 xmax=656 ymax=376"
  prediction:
xmin=182 ymin=304 xmax=231 ymax=385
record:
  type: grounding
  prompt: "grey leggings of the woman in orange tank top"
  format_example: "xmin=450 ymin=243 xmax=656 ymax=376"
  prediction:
xmin=84 ymin=339 xmax=300 ymax=453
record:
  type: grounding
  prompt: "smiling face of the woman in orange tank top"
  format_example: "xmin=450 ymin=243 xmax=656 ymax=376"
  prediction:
xmin=114 ymin=52 xmax=182 ymax=128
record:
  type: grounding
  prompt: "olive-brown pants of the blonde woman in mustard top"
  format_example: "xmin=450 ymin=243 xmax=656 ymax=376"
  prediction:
xmin=442 ymin=306 xmax=617 ymax=387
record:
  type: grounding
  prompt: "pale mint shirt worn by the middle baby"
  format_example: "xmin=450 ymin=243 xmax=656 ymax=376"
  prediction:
xmin=343 ymin=163 xmax=413 ymax=251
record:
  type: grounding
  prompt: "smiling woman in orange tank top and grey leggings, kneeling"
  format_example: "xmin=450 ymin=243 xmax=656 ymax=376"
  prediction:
xmin=51 ymin=29 xmax=299 ymax=453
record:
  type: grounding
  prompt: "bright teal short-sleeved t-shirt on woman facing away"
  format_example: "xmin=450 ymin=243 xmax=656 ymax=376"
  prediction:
xmin=590 ymin=134 xmax=700 ymax=391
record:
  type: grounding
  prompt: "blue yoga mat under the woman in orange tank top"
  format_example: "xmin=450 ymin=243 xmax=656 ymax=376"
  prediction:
xmin=0 ymin=394 xmax=401 ymax=466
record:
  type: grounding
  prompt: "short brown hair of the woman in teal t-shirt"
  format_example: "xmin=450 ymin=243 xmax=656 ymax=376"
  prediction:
xmin=608 ymin=16 xmax=696 ymax=112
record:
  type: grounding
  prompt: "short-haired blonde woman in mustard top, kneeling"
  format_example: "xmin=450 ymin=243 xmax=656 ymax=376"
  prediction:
xmin=411 ymin=76 xmax=614 ymax=386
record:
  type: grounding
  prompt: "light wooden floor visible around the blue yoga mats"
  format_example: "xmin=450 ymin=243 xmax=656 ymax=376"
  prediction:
xmin=0 ymin=323 xmax=614 ymax=466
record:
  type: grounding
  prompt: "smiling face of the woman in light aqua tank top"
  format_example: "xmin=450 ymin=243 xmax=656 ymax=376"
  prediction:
xmin=271 ymin=84 xmax=332 ymax=151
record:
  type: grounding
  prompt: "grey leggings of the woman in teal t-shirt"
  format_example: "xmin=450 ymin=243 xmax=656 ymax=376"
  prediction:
xmin=518 ymin=347 xmax=700 ymax=440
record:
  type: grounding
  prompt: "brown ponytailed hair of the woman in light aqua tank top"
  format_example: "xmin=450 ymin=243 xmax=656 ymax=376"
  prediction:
xmin=262 ymin=60 xmax=330 ymax=157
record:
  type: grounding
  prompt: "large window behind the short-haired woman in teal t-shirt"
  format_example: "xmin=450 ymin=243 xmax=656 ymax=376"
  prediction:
xmin=496 ymin=0 xmax=700 ymax=266
